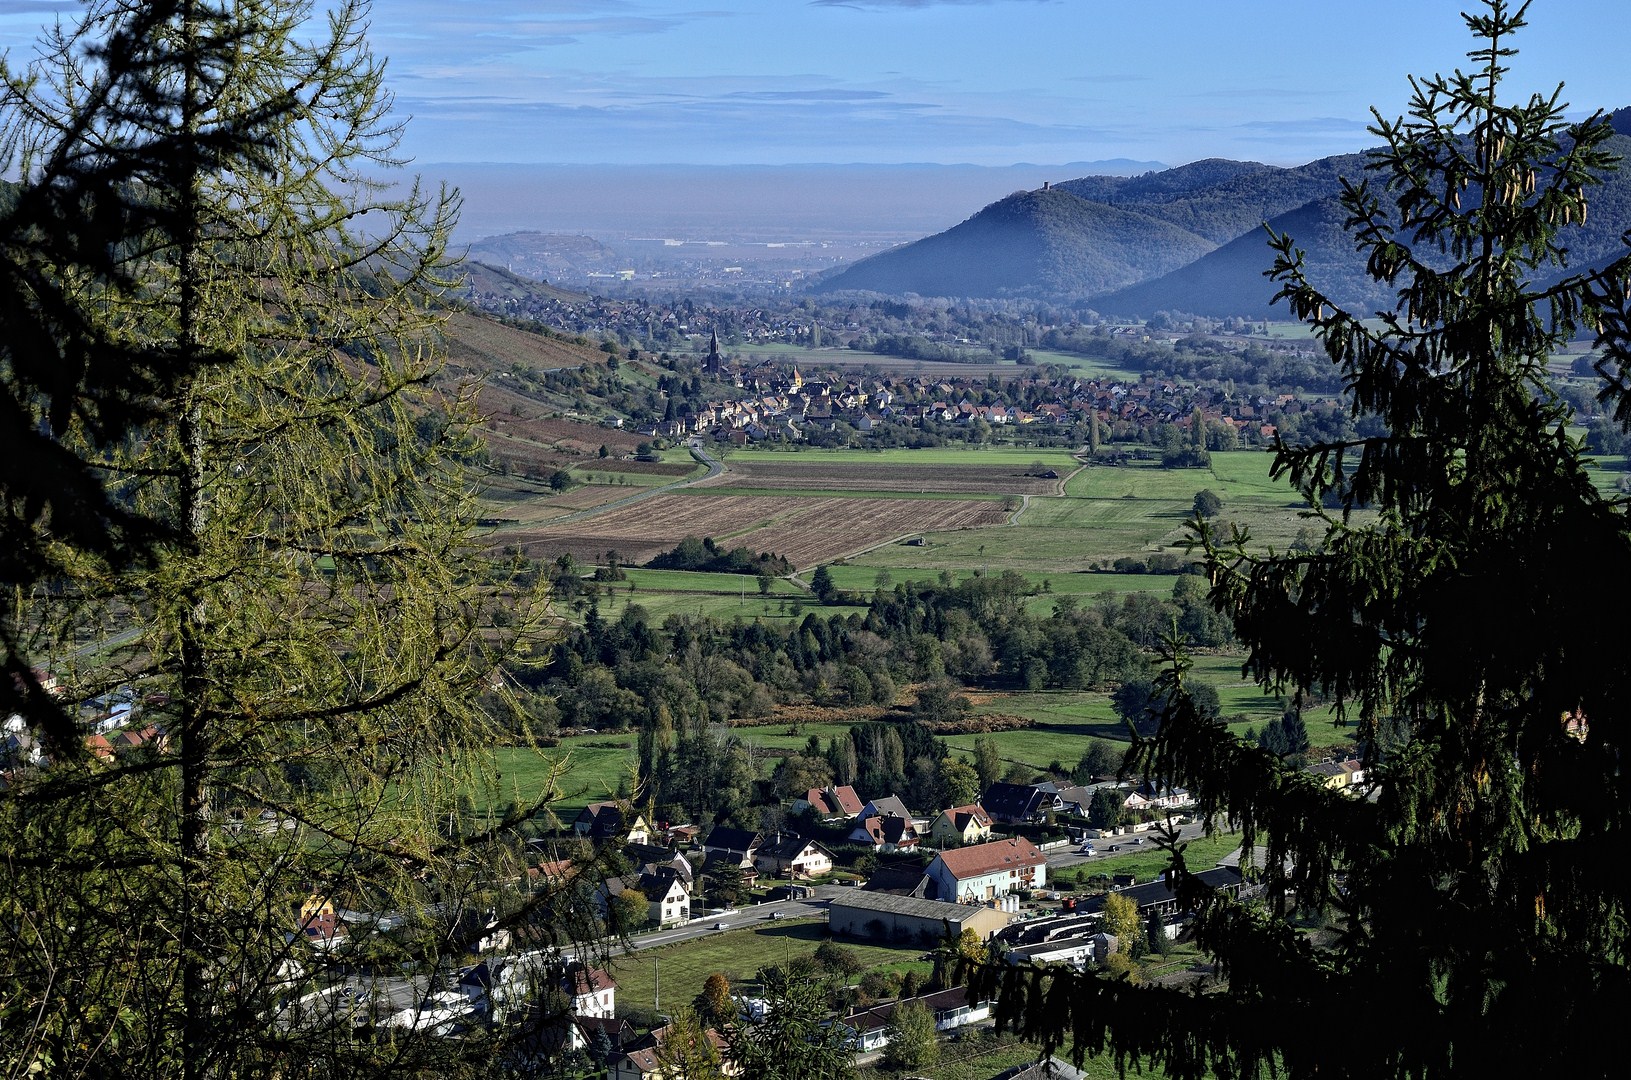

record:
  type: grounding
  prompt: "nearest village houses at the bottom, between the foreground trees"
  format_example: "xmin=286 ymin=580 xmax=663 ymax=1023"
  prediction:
xmin=280 ymin=770 xmax=1244 ymax=1080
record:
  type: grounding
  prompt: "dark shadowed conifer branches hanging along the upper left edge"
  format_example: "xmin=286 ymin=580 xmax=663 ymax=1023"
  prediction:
xmin=0 ymin=0 xmax=304 ymax=755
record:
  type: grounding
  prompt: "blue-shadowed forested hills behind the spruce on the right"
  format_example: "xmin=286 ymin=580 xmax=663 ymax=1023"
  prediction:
xmin=816 ymin=123 xmax=1631 ymax=318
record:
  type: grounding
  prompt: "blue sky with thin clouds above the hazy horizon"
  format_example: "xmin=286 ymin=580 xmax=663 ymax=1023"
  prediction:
xmin=0 ymin=0 xmax=1631 ymax=165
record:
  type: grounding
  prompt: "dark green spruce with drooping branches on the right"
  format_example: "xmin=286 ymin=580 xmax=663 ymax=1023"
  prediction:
xmin=987 ymin=0 xmax=1631 ymax=1077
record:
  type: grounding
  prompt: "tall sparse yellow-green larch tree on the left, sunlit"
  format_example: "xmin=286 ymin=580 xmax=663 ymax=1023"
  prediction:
xmin=0 ymin=0 xmax=561 ymax=1077
